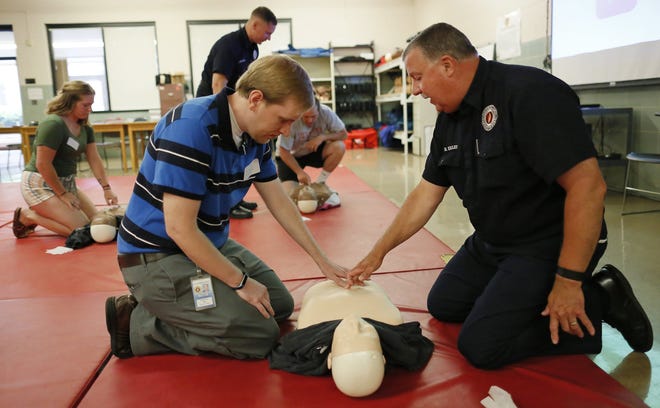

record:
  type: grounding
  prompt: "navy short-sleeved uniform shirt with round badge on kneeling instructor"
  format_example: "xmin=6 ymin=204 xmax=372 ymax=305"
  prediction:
xmin=423 ymin=58 xmax=596 ymax=256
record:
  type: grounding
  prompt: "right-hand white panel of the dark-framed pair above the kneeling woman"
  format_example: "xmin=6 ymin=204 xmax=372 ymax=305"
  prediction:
xmin=103 ymin=24 xmax=160 ymax=111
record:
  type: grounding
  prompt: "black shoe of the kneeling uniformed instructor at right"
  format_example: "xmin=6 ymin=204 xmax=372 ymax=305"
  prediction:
xmin=593 ymin=265 xmax=653 ymax=352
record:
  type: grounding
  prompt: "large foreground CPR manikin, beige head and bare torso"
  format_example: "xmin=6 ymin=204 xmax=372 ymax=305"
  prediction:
xmin=298 ymin=281 xmax=403 ymax=397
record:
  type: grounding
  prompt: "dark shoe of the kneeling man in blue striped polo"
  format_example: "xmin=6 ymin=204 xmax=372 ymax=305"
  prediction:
xmin=105 ymin=295 xmax=137 ymax=358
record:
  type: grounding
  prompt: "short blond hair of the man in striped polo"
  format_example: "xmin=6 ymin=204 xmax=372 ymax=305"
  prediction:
xmin=236 ymin=55 xmax=314 ymax=111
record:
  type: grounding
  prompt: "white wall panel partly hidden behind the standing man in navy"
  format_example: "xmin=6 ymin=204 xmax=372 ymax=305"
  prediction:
xmin=187 ymin=18 xmax=293 ymax=95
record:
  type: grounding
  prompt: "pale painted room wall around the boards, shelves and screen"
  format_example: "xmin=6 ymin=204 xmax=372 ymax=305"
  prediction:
xmin=6 ymin=0 xmax=660 ymax=201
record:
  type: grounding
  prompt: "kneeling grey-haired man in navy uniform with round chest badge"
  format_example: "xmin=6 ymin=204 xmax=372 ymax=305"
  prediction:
xmin=349 ymin=23 xmax=653 ymax=368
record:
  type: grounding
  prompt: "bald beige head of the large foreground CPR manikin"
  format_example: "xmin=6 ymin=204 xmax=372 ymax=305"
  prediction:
xmin=328 ymin=315 xmax=385 ymax=397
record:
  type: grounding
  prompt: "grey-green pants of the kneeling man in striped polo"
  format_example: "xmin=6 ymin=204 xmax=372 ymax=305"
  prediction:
xmin=122 ymin=239 xmax=293 ymax=359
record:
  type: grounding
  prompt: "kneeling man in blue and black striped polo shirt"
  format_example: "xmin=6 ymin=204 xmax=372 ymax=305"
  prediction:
xmin=106 ymin=55 xmax=346 ymax=358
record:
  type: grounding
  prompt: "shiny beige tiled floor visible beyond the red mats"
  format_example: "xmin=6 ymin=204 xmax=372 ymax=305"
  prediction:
xmin=0 ymin=148 xmax=660 ymax=407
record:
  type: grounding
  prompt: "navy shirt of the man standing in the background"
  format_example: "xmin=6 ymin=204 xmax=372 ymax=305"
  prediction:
xmin=196 ymin=27 xmax=259 ymax=97
